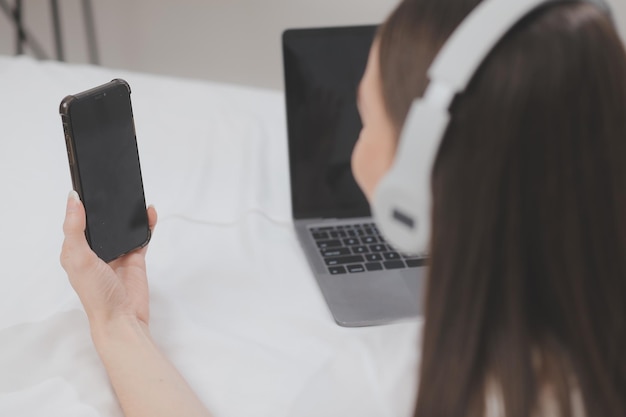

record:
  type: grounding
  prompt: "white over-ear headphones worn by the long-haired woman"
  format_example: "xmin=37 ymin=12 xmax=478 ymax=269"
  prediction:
xmin=371 ymin=0 xmax=611 ymax=254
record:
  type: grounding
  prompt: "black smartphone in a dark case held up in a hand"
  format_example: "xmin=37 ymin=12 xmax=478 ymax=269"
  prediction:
xmin=59 ymin=79 xmax=150 ymax=262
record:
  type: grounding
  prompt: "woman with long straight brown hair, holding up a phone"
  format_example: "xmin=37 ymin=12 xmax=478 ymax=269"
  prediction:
xmin=61 ymin=0 xmax=626 ymax=417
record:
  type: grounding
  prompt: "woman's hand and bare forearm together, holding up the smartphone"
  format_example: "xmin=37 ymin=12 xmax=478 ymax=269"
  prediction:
xmin=61 ymin=191 xmax=210 ymax=417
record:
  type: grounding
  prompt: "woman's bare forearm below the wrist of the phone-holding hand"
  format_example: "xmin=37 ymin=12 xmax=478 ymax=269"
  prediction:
xmin=92 ymin=317 xmax=210 ymax=417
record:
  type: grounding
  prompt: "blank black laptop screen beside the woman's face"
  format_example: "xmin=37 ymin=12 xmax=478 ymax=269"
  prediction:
xmin=283 ymin=26 xmax=377 ymax=219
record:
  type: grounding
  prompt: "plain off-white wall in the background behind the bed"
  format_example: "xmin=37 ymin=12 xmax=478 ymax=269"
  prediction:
xmin=0 ymin=0 xmax=626 ymax=89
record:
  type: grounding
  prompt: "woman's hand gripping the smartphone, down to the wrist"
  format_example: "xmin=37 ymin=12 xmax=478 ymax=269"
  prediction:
xmin=61 ymin=191 xmax=157 ymax=331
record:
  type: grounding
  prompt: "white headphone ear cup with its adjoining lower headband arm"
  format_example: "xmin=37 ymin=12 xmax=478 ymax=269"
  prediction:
xmin=371 ymin=99 xmax=450 ymax=254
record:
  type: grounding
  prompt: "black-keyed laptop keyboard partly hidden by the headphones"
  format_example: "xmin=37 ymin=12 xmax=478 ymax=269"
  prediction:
xmin=309 ymin=223 xmax=427 ymax=275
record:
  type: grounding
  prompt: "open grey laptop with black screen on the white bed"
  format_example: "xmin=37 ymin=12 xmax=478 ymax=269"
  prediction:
xmin=282 ymin=26 xmax=426 ymax=327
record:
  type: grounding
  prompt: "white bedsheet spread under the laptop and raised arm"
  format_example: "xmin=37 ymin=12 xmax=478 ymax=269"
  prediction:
xmin=0 ymin=56 xmax=420 ymax=417
